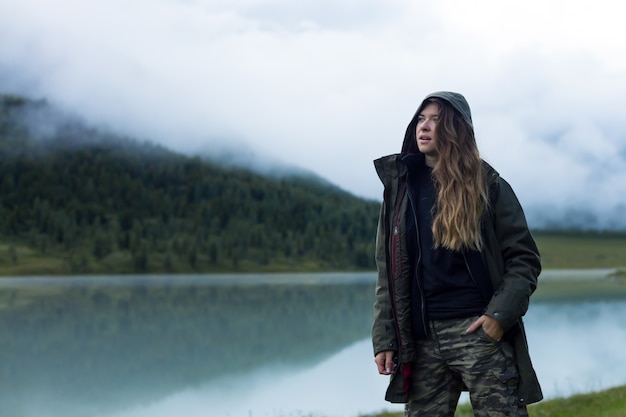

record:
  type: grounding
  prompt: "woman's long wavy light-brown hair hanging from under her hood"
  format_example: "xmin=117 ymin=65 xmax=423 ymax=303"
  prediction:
xmin=422 ymin=98 xmax=489 ymax=250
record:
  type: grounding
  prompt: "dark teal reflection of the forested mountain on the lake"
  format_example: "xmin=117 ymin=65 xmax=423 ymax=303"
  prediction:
xmin=0 ymin=276 xmax=373 ymax=417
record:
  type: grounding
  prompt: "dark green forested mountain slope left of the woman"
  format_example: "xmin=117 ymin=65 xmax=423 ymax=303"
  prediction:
xmin=0 ymin=95 xmax=379 ymax=273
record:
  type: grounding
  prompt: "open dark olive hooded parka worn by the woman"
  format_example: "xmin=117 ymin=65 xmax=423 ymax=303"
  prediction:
xmin=372 ymin=91 xmax=543 ymax=405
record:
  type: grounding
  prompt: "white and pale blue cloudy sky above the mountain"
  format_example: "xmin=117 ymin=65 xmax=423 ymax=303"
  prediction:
xmin=0 ymin=0 xmax=626 ymax=228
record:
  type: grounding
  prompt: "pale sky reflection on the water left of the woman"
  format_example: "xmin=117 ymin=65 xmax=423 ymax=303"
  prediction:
xmin=107 ymin=338 xmax=394 ymax=417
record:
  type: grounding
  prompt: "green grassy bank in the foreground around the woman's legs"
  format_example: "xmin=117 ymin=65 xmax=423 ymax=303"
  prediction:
xmin=361 ymin=385 xmax=626 ymax=417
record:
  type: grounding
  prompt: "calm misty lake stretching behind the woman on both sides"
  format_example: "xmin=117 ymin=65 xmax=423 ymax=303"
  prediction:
xmin=0 ymin=271 xmax=626 ymax=417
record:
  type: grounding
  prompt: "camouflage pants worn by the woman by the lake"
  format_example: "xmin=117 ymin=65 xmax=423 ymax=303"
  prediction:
xmin=405 ymin=317 xmax=528 ymax=417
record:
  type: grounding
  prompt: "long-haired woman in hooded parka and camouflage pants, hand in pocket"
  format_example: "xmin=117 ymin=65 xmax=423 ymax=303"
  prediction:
xmin=372 ymin=91 xmax=542 ymax=417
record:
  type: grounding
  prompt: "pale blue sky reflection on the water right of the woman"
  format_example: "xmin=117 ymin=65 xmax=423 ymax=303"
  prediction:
xmin=526 ymin=299 xmax=626 ymax=398
